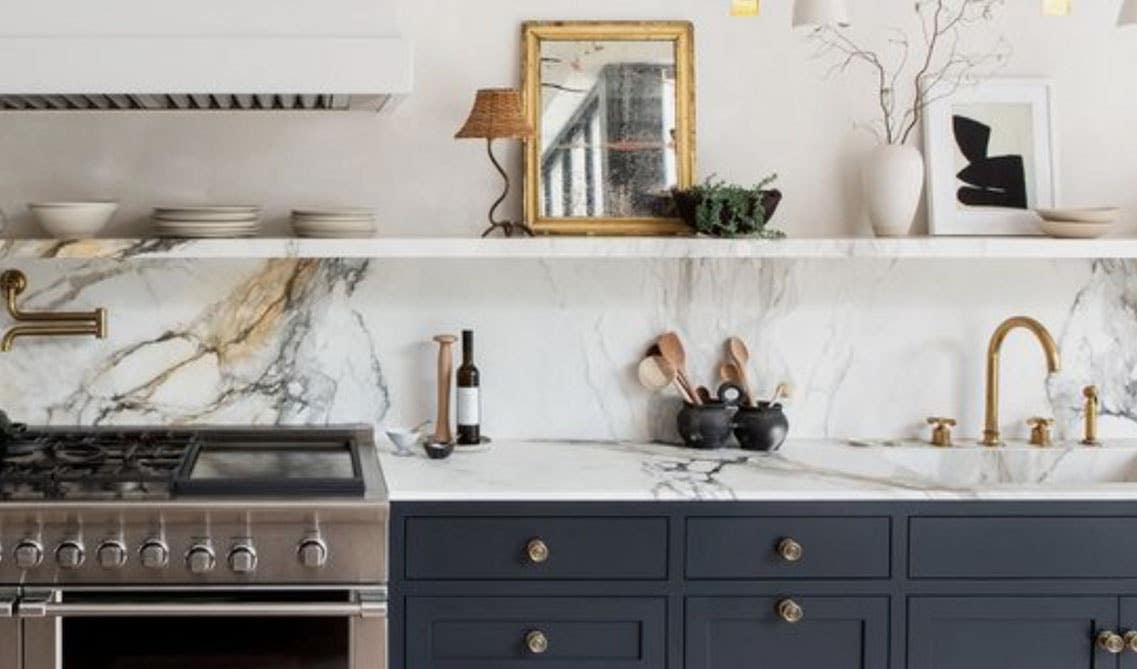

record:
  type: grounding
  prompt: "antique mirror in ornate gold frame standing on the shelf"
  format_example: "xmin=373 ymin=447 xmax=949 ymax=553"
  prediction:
xmin=522 ymin=22 xmax=695 ymax=234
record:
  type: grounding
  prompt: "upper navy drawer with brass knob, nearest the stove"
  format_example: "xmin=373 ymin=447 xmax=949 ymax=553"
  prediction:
xmin=406 ymin=518 xmax=667 ymax=580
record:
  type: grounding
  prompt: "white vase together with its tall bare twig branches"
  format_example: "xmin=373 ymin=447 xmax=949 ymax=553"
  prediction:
xmin=810 ymin=0 xmax=1010 ymax=237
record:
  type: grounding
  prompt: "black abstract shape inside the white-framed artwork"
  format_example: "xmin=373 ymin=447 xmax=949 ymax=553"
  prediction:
xmin=952 ymin=116 xmax=1027 ymax=209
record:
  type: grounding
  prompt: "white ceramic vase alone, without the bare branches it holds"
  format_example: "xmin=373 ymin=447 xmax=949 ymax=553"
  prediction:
xmin=862 ymin=144 xmax=924 ymax=237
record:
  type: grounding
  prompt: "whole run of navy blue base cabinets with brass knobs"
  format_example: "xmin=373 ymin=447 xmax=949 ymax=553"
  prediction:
xmin=390 ymin=502 xmax=1137 ymax=669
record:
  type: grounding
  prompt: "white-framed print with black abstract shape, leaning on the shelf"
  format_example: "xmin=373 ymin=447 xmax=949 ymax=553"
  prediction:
xmin=924 ymin=79 xmax=1059 ymax=237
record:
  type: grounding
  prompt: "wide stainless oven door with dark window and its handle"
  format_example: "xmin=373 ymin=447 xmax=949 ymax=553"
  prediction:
xmin=16 ymin=588 xmax=387 ymax=669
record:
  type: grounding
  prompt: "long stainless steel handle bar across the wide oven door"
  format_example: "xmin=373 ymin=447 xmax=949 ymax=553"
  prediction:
xmin=14 ymin=596 xmax=387 ymax=618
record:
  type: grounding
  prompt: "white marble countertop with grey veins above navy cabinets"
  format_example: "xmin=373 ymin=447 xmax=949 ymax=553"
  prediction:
xmin=380 ymin=440 xmax=1137 ymax=502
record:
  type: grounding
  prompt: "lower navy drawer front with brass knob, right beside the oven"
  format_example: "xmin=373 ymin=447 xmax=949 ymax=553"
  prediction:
xmin=406 ymin=597 xmax=666 ymax=669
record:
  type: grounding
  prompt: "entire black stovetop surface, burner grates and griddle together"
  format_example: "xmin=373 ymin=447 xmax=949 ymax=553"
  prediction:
xmin=0 ymin=420 xmax=370 ymax=501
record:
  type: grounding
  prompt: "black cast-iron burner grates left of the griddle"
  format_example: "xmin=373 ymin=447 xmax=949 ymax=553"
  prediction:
xmin=0 ymin=430 xmax=200 ymax=499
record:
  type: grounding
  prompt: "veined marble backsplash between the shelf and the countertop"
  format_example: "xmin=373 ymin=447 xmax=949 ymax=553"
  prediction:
xmin=0 ymin=259 xmax=1137 ymax=440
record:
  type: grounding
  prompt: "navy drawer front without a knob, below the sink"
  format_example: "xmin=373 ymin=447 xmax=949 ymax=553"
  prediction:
xmin=908 ymin=517 xmax=1137 ymax=579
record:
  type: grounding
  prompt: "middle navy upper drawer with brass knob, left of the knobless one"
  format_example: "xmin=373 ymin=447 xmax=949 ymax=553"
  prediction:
xmin=687 ymin=518 xmax=891 ymax=579
